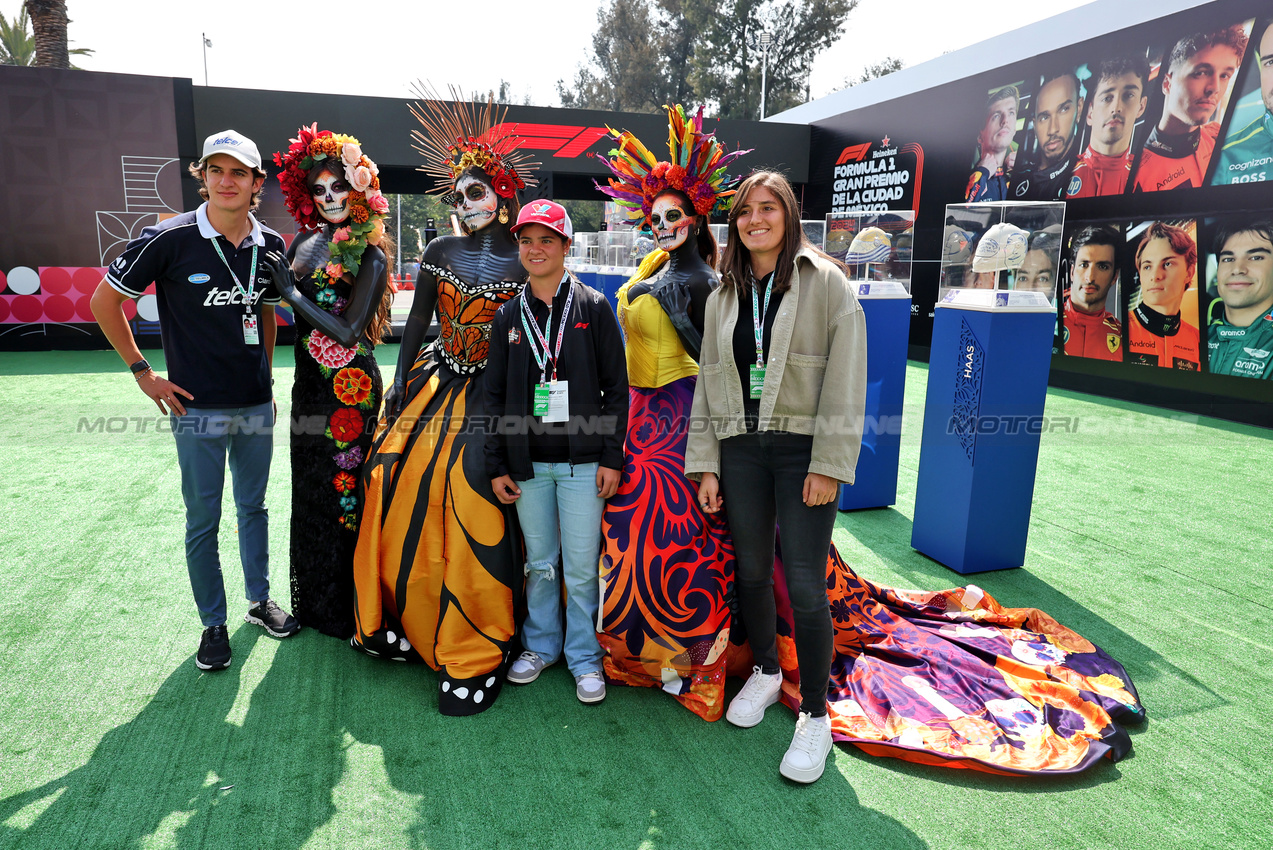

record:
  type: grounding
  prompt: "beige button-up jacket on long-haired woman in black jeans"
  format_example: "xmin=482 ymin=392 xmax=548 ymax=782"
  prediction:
xmin=685 ymin=248 xmax=867 ymax=484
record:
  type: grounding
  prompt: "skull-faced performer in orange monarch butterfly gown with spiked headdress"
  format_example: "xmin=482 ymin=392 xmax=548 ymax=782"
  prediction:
xmin=351 ymin=92 xmax=537 ymax=715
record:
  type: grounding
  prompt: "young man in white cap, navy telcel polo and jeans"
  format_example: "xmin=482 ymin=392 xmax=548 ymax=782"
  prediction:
xmin=92 ymin=130 xmax=299 ymax=671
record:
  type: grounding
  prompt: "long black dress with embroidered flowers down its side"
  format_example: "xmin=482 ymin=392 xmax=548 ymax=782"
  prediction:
xmin=290 ymin=265 xmax=381 ymax=639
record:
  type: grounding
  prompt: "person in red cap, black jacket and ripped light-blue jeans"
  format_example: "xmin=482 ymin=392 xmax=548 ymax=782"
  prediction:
xmin=485 ymin=201 xmax=628 ymax=702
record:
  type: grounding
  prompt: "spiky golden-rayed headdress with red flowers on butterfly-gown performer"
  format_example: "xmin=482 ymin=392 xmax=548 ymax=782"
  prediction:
xmin=410 ymin=83 xmax=540 ymax=197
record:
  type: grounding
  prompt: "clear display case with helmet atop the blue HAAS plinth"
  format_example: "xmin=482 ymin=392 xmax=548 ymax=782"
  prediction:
xmin=937 ymin=201 xmax=1066 ymax=312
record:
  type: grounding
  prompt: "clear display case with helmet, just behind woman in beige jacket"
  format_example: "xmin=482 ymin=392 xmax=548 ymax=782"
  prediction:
xmin=822 ymin=210 xmax=915 ymax=298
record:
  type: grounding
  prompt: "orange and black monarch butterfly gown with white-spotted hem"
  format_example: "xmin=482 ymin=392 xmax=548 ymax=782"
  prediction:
xmin=353 ymin=263 xmax=524 ymax=715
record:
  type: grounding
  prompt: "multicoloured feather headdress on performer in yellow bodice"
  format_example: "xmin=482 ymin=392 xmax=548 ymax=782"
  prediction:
xmin=597 ymin=104 xmax=751 ymax=232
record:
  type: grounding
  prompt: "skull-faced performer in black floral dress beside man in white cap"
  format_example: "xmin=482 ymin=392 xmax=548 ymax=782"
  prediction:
xmin=269 ymin=125 xmax=392 ymax=639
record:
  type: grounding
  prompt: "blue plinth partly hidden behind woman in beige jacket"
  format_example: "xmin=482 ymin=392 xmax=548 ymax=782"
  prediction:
xmin=840 ymin=298 xmax=910 ymax=510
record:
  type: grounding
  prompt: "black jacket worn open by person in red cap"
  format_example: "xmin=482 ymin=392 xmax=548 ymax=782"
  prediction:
xmin=484 ymin=275 xmax=628 ymax=481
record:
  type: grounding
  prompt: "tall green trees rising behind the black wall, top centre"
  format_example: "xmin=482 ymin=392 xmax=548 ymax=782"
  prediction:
xmin=558 ymin=0 xmax=858 ymax=118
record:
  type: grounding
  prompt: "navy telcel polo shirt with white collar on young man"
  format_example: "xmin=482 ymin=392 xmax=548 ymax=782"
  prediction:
xmin=106 ymin=202 xmax=286 ymax=407
